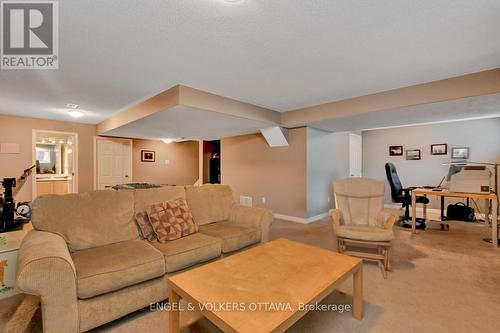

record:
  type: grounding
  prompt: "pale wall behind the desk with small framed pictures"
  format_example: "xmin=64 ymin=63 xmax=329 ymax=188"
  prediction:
xmin=363 ymin=118 xmax=500 ymax=208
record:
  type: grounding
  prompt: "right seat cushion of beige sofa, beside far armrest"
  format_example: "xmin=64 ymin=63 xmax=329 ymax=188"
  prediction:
xmin=200 ymin=221 xmax=261 ymax=253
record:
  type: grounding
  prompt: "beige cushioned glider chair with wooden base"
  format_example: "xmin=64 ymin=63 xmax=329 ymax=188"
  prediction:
xmin=329 ymin=178 xmax=396 ymax=278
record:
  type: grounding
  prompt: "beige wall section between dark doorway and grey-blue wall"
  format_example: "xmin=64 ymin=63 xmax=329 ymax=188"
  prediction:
xmin=221 ymin=128 xmax=307 ymax=217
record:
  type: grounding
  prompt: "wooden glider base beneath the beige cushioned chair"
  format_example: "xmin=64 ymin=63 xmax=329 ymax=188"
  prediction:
xmin=337 ymin=238 xmax=392 ymax=279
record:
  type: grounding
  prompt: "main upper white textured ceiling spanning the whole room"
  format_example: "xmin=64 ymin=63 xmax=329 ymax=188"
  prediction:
xmin=0 ymin=0 xmax=500 ymax=123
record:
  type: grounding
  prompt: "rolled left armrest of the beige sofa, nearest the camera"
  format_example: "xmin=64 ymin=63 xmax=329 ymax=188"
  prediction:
xmin=16 ymin=230 xmax=79 ymax=332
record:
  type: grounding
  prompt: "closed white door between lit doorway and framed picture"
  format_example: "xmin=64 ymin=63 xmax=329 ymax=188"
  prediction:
xmin=96 ymin=138 xmax=132 ymax=190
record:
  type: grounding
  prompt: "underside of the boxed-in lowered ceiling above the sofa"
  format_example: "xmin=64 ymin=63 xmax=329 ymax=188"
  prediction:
xmin=100 ymin=106 xmax=276 ymax=140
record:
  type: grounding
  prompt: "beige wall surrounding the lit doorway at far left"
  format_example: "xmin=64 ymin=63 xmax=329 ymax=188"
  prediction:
xmin=0 ymin=115 xmax=96 ymax=201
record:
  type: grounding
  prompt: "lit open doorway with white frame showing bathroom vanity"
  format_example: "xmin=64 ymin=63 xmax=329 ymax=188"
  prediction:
xmin=31 ymin=130 xmax=78 ymax=199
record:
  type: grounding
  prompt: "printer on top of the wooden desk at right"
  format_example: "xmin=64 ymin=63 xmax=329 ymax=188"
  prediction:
xmin=449 ymin=166 xmax=492 ymax=193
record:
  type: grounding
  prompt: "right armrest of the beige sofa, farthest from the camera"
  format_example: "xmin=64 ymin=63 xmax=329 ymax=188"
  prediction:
xmin=229 ymin=204 xmax=274 ymax=243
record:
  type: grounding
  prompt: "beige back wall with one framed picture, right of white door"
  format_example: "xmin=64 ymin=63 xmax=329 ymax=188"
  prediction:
xmin=132 ymin=139 xmax=198 ymax=185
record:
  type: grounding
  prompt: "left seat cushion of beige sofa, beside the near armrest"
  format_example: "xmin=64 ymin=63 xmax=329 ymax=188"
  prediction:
xmin=71 ymin=239 xmax=165 ymax=298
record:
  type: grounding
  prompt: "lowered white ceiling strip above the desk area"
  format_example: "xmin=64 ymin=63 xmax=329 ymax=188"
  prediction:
xmin=308 ymin=94 xmax=500 ymax=132
